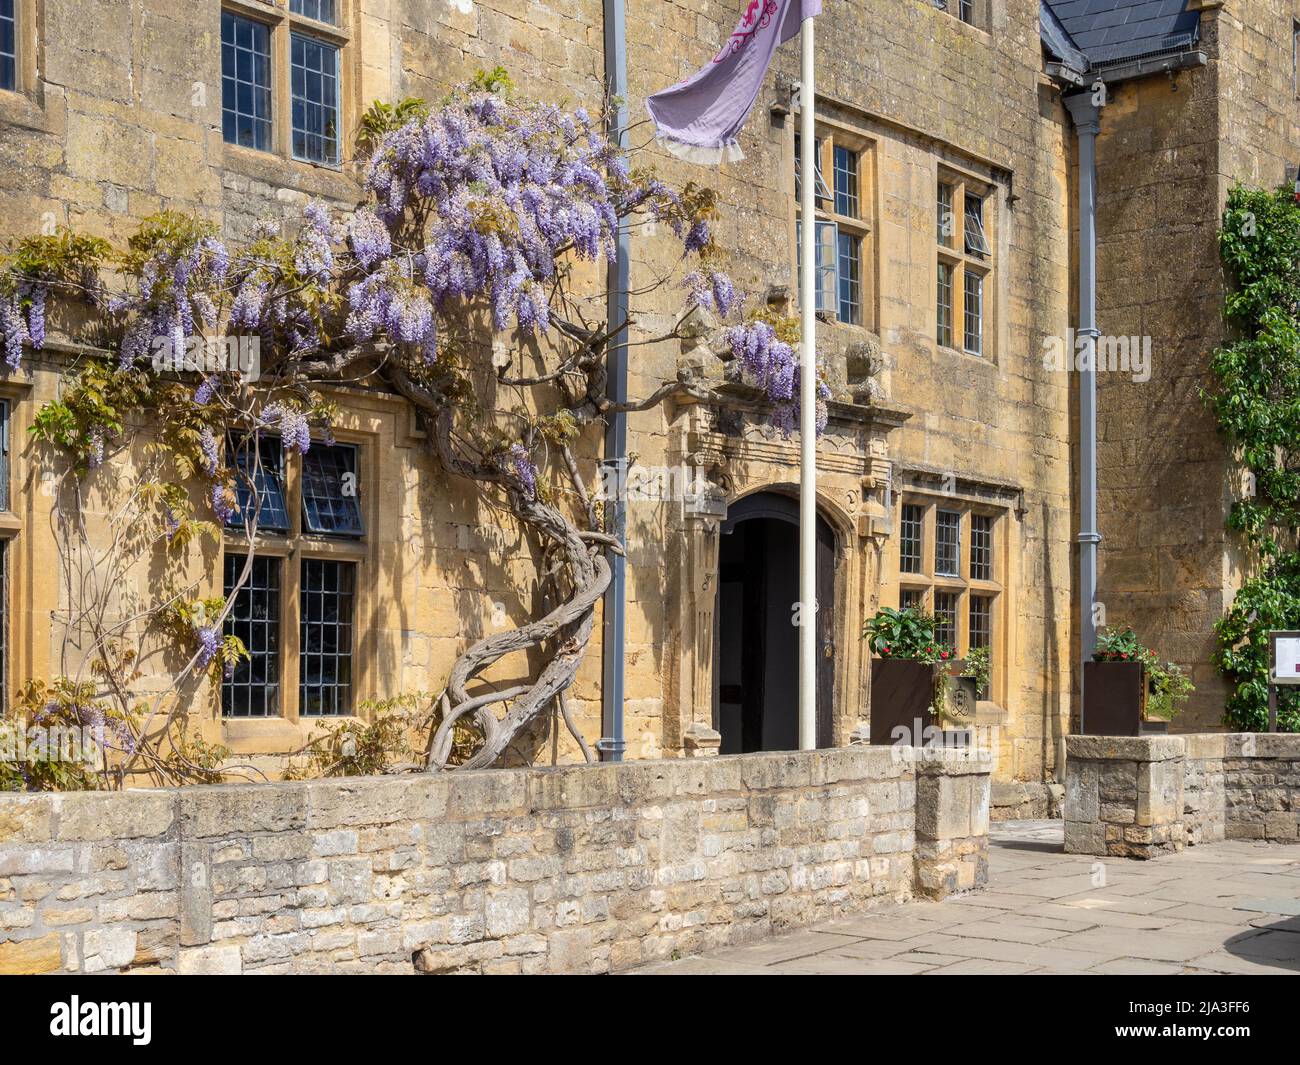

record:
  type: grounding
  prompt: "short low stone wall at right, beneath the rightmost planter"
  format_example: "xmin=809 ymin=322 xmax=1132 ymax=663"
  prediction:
xmin=1065 ymin=732 xmax=1300 ymax=858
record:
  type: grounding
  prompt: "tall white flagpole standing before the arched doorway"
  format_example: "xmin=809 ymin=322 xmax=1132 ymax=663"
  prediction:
xmin=798 ymin=18 xmax=816 ymax=750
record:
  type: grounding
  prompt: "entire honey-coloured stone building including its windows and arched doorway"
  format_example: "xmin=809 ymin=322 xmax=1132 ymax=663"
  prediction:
xmin=0 ymin=0 xmax=1279 ymax=817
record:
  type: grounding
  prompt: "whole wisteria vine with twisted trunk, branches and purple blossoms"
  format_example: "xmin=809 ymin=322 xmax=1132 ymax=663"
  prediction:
xmin=0 ymin=70 xmax=829 ymax=785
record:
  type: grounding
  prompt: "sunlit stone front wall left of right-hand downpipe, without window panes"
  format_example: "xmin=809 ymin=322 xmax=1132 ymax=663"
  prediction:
xmin=0 ymin=0 xmax=1071 ymax=805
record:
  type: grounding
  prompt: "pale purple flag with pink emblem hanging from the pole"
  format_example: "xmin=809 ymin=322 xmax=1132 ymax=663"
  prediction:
xmin=646 ymin=0 xmax=822 ymax=163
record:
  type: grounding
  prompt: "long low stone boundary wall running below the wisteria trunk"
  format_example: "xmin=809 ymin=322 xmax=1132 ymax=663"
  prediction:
xmin=0 ymin=746 xmax=991 ymax=973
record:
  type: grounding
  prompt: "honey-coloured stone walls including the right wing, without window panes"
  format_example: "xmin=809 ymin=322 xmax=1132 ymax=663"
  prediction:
xmin=0 ymin=0 xmax=1296 ymax=801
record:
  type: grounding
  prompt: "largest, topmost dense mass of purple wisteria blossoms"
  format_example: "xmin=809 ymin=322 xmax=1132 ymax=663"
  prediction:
xmin=350 ymin=92 xmax=642 ymax=335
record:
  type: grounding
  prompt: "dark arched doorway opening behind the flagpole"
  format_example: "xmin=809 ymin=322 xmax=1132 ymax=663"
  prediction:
xmin=714 ymin=492 xmax=835 ymax=754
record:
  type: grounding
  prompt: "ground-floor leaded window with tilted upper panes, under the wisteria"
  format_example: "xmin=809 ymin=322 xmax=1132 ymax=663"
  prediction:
xmin=221 ymin=434 xmax=365 ymax=718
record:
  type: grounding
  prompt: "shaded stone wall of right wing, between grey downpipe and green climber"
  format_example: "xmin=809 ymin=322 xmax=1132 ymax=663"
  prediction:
xmin=1097 ymin=0 xmax=1300 ymax=732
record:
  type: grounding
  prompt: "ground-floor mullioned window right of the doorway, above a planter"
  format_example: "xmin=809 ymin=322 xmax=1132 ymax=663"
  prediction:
xmin=897 ymin=497 xmax=1004 ymax=698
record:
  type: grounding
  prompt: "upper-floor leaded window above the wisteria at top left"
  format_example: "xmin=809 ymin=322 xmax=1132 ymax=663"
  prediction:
xmin=222 ymin=0 xmax=348 ymax=166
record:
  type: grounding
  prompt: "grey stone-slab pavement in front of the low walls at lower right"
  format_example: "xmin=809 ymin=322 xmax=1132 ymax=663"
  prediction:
xmin=632 ymin=821 xmax=1300 ymax=975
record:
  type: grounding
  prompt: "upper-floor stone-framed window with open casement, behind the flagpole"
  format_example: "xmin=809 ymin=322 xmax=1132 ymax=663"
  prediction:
xmin=794 ymin=130 xmax=870 ymax=325
